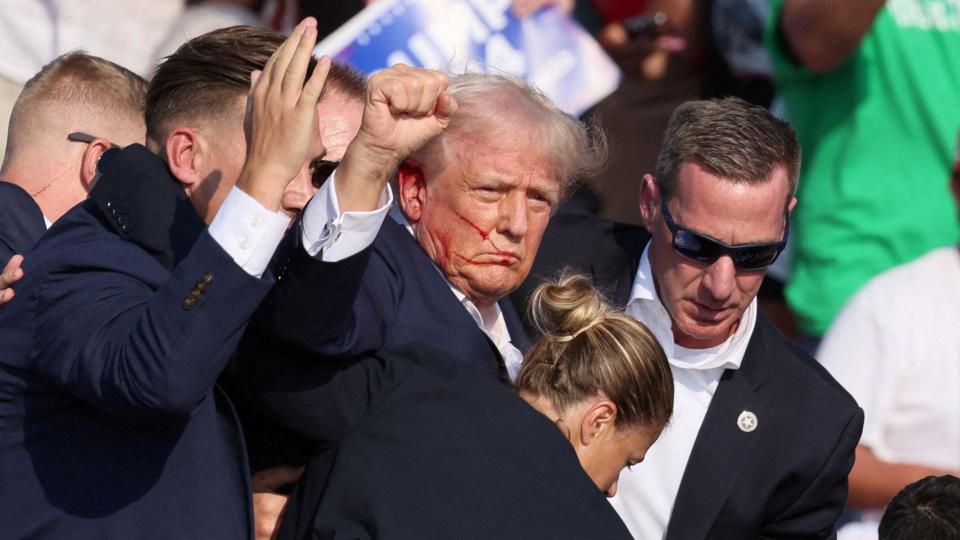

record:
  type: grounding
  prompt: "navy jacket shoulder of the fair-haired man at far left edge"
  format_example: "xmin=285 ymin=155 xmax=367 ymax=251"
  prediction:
xmin=0 ymin=182 xmax=47 ymax=262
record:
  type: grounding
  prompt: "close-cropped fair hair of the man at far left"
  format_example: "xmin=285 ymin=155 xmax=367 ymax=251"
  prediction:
xmin=6 ymin=51 xmax=147 ymax=155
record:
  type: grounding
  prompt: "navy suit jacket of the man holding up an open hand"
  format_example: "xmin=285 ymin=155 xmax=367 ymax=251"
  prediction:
xmin=0 ymin=146 xmax=271 ymax=540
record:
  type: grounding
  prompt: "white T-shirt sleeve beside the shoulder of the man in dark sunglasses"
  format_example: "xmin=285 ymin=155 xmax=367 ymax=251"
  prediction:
xmin=817 ymin=282 xmax=900 ymax=450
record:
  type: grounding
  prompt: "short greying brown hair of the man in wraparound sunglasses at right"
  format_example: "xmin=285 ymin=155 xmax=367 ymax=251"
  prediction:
xmin=655 ymin=98 xmax=800 ymax=207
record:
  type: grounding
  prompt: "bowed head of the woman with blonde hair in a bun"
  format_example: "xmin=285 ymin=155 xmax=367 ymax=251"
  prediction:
xmin=516 ymin=275 xmax=673 ymax=497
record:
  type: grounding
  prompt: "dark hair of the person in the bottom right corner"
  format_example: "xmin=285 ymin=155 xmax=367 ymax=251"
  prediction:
xmin=880 ymin=474 xmax=960 ymax=540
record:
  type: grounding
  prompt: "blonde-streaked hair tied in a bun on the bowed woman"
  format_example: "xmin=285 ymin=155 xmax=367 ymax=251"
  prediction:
xmin=516 ymin=274 xmax=673 ymax=427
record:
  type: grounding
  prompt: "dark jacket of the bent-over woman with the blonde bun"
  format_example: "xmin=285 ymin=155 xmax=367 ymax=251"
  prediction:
xmin=239 ymin=343 xmax=630 ymax=540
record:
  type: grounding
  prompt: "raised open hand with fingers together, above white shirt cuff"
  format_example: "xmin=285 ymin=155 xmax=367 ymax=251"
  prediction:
xmin=237 ymin=17 xmax=330 ymax=210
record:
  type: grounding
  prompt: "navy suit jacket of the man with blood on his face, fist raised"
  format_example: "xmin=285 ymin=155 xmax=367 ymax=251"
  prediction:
xmin=235 ymin=217 xmax=529 ymax=470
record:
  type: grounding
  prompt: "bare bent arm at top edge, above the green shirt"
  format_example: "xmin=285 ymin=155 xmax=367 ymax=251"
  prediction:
xmin=778 ymin=0 xmax=886 ymax=73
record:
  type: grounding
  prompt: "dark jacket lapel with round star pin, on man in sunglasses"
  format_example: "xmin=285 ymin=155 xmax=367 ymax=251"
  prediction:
xmin=666 ymin=313 xmax=773 ymax=540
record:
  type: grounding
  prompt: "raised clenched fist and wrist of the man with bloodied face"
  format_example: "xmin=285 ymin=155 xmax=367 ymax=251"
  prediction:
xmin=336 ymin=64 xmax=457 ymax=212
